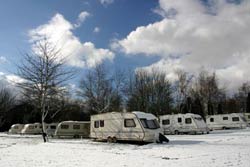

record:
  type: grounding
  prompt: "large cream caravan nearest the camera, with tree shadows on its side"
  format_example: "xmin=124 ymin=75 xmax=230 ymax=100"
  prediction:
xmin=90 ymin=111 xmax=168 ymax=142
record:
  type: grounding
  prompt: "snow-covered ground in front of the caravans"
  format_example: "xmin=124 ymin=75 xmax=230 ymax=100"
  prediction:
xmin=0 ymin=129 xmax=250 ymax=167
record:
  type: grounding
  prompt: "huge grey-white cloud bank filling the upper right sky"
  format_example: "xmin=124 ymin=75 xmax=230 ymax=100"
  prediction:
xmin=114 ymin=0 xmax=250 ymax=90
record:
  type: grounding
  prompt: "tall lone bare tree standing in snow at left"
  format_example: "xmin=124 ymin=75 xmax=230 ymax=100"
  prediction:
xmin=17 ymin=39 xmax=74 ymax=142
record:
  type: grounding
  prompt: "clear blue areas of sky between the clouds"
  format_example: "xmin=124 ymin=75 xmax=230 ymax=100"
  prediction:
xmin=0 ymin=0 xmax=161 ymax=72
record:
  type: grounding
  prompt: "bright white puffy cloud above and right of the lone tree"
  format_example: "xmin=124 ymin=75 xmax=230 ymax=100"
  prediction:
xmin=29 ymin=14 xmax=115 ymax=67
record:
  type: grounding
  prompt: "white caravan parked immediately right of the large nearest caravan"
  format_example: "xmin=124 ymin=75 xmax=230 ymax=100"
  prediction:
xmin=160 ymin=113 xmax=209 ymax=134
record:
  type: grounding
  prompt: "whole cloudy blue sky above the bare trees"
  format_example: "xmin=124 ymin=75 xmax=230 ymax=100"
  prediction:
xmin=0 ymin=0 xmax=250 ymax=94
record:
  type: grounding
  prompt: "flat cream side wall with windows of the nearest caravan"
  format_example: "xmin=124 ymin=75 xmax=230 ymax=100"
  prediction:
xmin=90 ymin=112 xmax=144 ymax=141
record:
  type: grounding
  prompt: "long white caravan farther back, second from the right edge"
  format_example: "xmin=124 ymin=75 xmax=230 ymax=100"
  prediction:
xmin=206 ymin=113 xmax=247 ymax=130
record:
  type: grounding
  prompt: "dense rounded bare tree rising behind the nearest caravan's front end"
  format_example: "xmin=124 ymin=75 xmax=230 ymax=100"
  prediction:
xmin=127 ymin=70 xmax=172 ymax=115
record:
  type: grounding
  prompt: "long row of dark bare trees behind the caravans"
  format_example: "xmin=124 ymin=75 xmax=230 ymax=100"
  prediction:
xmin=0 ymin=65 xmax=250 ymax=131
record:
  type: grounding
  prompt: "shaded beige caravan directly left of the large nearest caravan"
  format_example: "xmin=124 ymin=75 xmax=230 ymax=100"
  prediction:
xmin=55 ymin=121 xmax=90 ymax=138
